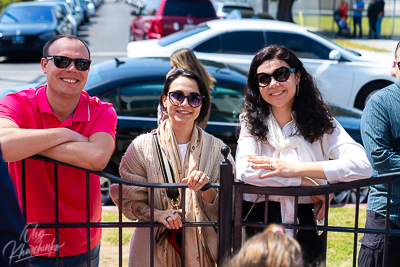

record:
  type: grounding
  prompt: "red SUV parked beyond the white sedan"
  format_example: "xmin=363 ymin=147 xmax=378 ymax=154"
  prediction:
xmin=129 ymin=0 xmax=218 ymax=41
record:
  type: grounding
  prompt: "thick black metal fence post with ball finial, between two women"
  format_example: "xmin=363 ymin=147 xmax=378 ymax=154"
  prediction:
xmin=218 ymin=146 xmax=234 ymax=266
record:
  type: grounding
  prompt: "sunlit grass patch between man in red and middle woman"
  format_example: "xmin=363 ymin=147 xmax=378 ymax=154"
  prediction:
xmin=101 ymin=211 xmax=134 ymax=246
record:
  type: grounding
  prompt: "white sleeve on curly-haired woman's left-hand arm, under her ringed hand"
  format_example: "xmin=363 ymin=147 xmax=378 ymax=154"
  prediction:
xmin=236 ymin=117 xmax=301 ymax=187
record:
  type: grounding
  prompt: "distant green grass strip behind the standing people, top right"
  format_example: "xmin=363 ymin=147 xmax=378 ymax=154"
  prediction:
xmin=293 ymin=14 xmax=400 ymax=37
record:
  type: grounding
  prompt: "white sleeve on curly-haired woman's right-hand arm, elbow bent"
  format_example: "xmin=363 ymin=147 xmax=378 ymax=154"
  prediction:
xmin=322 ymin=119 xmax=372 ymax=183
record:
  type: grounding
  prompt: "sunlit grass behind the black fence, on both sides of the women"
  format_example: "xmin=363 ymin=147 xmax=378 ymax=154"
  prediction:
xmin=101 ymin=207 xmax=365 ymax=267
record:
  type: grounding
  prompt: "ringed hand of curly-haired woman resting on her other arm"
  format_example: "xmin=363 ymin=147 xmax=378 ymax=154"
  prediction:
xmin=247 ymin=156 xmax=298 ymax=178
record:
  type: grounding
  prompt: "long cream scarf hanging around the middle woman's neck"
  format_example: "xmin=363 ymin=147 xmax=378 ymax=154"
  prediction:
xmin=157 ymin=120 xmax=217 ymax=267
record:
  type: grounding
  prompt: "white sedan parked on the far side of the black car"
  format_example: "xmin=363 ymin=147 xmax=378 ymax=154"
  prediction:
xmin=127 ymin=19 xmax=395 ymax=109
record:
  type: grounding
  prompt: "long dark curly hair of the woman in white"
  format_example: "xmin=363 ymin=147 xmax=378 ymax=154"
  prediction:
xmin=242 ymin=45 xmax=334 ymax=143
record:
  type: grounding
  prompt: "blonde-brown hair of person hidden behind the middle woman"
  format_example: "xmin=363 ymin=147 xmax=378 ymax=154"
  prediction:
xmin=170 ymin=48 xmax=216 ymax=93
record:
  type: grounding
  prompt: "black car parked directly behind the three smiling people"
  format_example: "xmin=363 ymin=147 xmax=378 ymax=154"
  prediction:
xmin=0 ymin=58 xmax=368 ymax=204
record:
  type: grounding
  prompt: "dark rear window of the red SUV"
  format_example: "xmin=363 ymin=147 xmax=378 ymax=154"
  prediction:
xmin=164 ymin=0 xmax=215 ymax=18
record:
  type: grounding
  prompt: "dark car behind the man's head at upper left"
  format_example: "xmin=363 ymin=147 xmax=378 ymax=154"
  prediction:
xmin=0 ymin=2 xmax=73 ymax=57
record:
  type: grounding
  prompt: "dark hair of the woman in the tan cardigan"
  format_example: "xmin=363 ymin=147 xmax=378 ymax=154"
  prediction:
xmin=158 ymin=69 xmax=211 ymax=123
